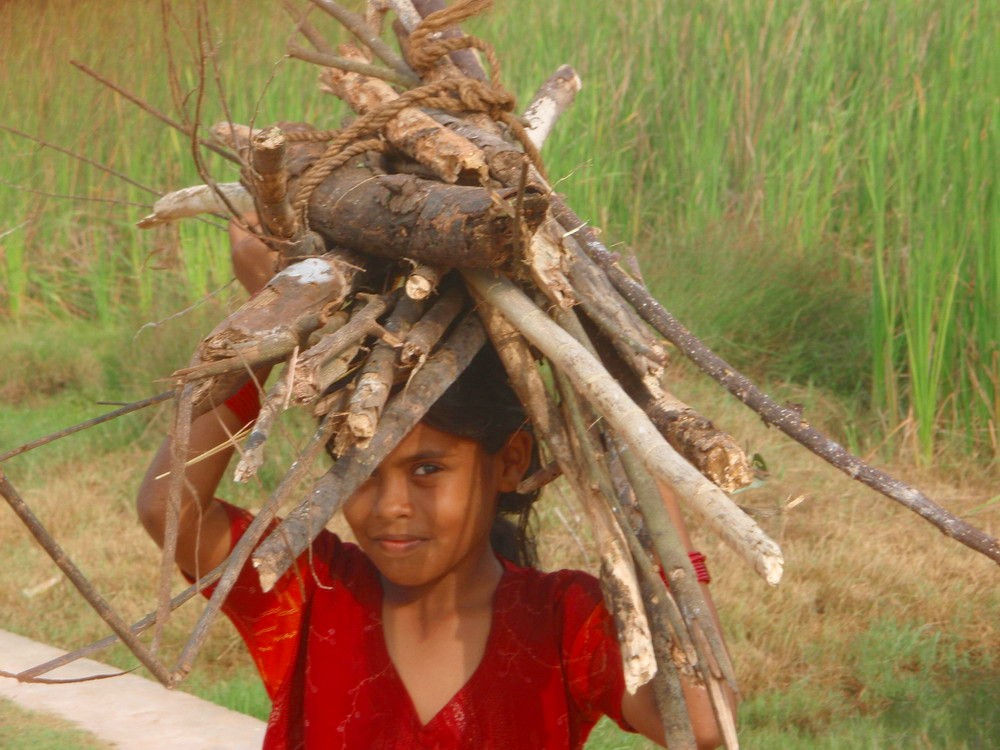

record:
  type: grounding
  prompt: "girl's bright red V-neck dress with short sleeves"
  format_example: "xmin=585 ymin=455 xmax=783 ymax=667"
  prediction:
xmin=211 ymin=505 xmax=628 ymax=750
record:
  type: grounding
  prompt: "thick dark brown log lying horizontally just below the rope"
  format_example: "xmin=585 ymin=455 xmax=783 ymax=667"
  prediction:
xmin=309 ymin=161 xmax=548 ymax=268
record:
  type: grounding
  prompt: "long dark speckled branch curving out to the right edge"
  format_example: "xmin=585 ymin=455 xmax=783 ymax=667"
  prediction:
xmin=554 ymin=203 xmax=1000 ymax=564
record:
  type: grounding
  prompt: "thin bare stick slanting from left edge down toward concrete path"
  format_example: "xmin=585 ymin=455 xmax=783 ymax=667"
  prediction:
xmin=0 ymin=469 xmax=171 ymax=687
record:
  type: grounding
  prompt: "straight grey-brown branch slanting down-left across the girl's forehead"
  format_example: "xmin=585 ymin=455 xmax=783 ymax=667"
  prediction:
xmin=253 ymin=314 xmax=486 ymax=591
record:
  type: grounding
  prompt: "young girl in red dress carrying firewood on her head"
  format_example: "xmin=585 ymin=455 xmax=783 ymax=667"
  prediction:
xmin=138 ymin=220 xmax=732 ymax=750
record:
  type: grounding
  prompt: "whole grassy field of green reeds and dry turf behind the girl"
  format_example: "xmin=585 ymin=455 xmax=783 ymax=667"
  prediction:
xmin=0 ymin=0 xmax=1000 ymax=750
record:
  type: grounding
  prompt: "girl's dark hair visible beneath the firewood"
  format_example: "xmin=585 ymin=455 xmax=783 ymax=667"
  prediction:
xmin=423 ymin=343 xmax=540 ymax=567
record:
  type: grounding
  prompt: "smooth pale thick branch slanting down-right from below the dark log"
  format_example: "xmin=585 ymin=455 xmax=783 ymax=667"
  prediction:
xmin=463 ymin=271 xmax=783 ymax=585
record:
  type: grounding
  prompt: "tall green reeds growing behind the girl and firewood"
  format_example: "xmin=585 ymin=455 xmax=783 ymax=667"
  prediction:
xmin=0 ymin=0 xmax=1000 ymax=460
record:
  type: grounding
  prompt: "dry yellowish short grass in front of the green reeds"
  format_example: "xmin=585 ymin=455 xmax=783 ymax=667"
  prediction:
xmin=0 ymin=362 xmax=1000 ymax=748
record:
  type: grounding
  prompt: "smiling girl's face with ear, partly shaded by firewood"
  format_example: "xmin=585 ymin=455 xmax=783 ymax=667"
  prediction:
xmin=344 ymin=423 xmax=531 ymax=587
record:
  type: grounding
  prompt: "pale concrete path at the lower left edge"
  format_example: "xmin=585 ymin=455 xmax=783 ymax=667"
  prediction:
xmin=0 ymin=630 xmax=264 ymax=750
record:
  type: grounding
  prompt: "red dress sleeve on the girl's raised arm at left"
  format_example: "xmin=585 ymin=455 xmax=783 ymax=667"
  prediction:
xmin=188 ymin=500 xmax=340 ymax=699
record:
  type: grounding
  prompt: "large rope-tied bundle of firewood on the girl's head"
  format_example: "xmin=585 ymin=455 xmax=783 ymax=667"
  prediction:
xmin=5 ymin=0 xmax=1000 ymax=747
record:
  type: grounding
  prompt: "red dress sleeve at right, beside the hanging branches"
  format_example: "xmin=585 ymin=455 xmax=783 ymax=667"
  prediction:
xmin=563 ymin=574 xmax=635 ymax=732
